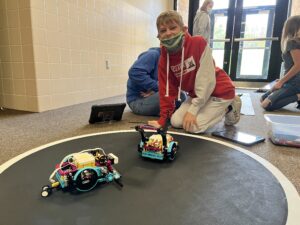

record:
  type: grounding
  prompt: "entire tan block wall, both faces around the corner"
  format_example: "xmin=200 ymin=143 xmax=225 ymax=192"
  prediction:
xmin=0 ymin=0 xmax=172 ymax=112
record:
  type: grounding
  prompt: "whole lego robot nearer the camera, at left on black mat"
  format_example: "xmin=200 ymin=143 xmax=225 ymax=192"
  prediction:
xmin=41 ymin=148 xmax=123 ymax=197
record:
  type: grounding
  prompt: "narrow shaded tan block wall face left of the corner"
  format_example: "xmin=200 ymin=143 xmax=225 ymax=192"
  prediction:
xmin=0 ymin=0 xmax=36 ymax=110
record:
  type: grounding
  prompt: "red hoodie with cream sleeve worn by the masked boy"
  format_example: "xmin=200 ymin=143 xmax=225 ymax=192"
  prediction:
xmin=158 ymin=32 xmax=235 ymax=126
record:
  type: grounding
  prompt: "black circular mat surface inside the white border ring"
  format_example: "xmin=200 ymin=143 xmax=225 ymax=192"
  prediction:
xmin=0 ymin=131 xmax=288 ymax=225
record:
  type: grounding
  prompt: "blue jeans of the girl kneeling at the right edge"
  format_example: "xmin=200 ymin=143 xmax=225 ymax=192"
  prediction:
xmin=261 ymin=83 xmax=300 ymax=111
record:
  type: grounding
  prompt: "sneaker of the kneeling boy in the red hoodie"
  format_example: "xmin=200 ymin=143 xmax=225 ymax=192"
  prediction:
xmin=225 ymin=95 xmax=242 ymax=126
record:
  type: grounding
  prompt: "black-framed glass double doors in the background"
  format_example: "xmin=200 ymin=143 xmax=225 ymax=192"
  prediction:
xmin=175 ymin=0 xmax=288 ymax=81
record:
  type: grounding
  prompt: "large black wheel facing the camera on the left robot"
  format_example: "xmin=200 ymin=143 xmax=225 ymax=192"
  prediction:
xmin=74 ymin=169 xmax=98 ymax=191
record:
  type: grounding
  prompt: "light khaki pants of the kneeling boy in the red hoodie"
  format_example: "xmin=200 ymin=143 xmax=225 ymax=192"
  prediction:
xmin=171 ymin=97 xmax=234 ymax=133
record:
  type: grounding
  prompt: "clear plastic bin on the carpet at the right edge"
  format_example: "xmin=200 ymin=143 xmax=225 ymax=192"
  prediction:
xmin=264 ymin=114 xmax=300 ymax=148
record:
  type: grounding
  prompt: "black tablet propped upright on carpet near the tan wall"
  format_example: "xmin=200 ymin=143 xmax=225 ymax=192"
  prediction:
xmin=89 ymin=103 xmax=126 ymax=124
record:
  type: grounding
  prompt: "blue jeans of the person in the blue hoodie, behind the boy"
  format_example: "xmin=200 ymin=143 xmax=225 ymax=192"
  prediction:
xmin=128 ymin=92 xmax=186 ymax=116
